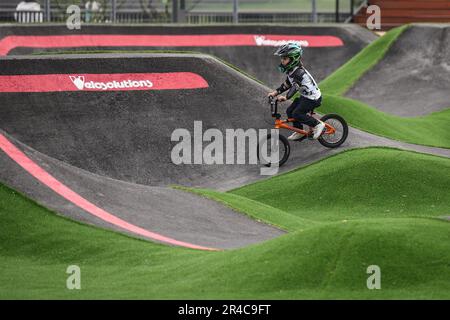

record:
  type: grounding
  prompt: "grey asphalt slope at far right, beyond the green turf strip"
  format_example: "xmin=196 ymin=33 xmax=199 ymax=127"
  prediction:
xmin=346 ymin=24 xmax=450 ymax=117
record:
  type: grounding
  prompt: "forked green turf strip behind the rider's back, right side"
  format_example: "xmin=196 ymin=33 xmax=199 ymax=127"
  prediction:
xmin=317 ymin=26 xmax=450 ymax=148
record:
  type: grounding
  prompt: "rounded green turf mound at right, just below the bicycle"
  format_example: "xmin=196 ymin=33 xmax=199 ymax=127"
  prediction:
xmin=232 ymin=148 xmax=450 ymax=221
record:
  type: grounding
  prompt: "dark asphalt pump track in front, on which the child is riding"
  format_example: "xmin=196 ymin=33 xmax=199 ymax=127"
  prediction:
xmin=0 ymin=54 xmax=450 ymax=248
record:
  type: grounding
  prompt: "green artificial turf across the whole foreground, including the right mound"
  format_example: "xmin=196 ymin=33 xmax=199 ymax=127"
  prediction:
xmin=0 ymin=149 xmax=450 ymax=299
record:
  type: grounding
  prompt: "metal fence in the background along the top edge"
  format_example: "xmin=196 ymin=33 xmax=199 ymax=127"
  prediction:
xmin=0 ymin=0 xmax=362 ymax=24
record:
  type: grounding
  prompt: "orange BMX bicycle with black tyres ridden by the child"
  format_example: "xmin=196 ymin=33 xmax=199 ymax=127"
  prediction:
xmin=257 ymin=97 xmax=348 ymax=167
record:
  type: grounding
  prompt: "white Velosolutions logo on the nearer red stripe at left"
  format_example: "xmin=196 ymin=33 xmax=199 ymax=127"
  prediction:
xmin=69 ymin=76 xmax=153 ymax=91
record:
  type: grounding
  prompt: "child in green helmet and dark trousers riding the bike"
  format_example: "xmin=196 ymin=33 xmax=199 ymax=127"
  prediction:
xmin=268 ymin=43 xmax=325 ymax=140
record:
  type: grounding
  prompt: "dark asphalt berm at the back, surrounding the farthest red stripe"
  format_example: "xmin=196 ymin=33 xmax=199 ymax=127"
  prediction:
xmin=0 ymin=24 xmax=376 ymax=87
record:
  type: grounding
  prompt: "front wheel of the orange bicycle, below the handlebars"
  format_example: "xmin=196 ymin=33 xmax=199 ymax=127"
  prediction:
xmin=257 ymin=133 xmax=291 ymax=167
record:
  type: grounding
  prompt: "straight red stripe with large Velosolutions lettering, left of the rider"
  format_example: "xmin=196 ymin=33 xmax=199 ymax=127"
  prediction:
xmin=0 ymin=72 xmax=208 ymax=92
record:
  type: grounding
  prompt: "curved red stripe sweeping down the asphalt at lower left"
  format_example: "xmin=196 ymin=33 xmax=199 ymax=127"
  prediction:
xmin=0 ymin=133 xmax=217 ymax=251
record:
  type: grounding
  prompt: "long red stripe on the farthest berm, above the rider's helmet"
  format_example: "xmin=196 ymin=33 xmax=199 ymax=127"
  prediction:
xmin=0 ymin=34 xmax=344 ymax=56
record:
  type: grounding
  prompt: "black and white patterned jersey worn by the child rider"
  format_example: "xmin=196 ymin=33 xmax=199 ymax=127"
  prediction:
xmin=286 ymin=67 xmax=322 ymax=100
